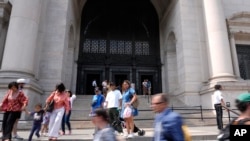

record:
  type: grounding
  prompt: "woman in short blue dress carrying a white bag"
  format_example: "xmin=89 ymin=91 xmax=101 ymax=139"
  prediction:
xmin=121 ymin=80 xmax=138 ymax=138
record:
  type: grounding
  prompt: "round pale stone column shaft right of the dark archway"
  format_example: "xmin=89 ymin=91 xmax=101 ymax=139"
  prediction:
xmin=203 ymin=0 xmax=235 ymax=81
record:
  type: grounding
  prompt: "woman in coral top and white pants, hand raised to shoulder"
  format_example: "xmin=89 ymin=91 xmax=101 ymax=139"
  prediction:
xmin=46 ymin=83 xmax=70 ymax=140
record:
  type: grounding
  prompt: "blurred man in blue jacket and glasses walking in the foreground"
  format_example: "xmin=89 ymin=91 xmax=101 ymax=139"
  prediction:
xmin=151 ymin=93 xmax=184 ymax=141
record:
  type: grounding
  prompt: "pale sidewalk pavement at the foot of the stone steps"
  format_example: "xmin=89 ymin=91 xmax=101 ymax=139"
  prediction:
xmin=7 ymin=126 xmax=219 ymax=141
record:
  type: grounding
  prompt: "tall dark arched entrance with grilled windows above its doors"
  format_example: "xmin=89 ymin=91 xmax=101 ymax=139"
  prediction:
xmin=76 ymin=0 xmax=161 ymax=94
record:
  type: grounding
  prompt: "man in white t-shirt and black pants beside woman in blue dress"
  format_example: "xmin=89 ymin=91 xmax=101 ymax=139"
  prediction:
xmin=105 ymin=82 xmax=123 ymax=134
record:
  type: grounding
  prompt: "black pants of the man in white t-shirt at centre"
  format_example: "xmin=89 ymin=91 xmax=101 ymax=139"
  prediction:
xmin=108 ymin=108 xmax=123 ymax=133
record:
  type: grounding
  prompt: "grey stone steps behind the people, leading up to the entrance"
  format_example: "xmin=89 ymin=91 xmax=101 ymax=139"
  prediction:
xmin=0 ymin=95 xmax=235 ymax=129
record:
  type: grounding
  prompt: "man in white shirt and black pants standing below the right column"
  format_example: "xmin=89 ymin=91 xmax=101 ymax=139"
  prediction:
xmin=213 ymin=85 xmax=225 ymax=130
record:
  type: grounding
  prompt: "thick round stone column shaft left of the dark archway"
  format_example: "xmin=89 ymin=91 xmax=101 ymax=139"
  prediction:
xmin=0 ymin=0 xmax=41 ymax=78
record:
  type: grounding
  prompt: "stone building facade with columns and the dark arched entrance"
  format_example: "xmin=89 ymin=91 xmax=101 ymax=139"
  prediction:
xmin=0 ymin=0 xmax=250 ymax=108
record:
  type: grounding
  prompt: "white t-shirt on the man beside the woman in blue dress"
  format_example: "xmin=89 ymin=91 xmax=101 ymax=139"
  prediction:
xmin=105 ymin=90 xmax=122 ymax=108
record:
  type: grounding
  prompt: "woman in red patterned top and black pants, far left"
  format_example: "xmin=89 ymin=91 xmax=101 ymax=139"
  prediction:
xmin=0 ymin=82 xmax=28 ymax=141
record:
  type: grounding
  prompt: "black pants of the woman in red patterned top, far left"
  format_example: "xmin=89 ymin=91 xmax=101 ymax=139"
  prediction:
xmin=2 ymin=111 xmax=20 ymax=140
